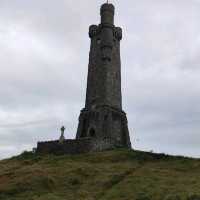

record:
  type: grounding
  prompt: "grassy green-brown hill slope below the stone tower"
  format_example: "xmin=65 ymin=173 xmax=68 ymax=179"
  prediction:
xmin=0 ymin=150 xmax=200 ymax=200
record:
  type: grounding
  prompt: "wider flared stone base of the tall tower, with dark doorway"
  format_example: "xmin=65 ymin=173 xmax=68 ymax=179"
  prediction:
xmin=76 ymin=105 xmax=131 ymax=148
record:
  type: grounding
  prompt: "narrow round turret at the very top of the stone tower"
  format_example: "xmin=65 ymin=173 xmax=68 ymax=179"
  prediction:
xmin=100 ymin=2 xmax=115 ymax=24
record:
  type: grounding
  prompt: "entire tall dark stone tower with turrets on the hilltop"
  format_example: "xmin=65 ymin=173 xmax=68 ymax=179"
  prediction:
xmin=76 ymin=3 xmax=131 ymax=148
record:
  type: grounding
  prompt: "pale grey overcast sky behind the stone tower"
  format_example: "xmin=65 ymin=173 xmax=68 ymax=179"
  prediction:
xmin=0 ymin=0 xmax=200 ymax=159
